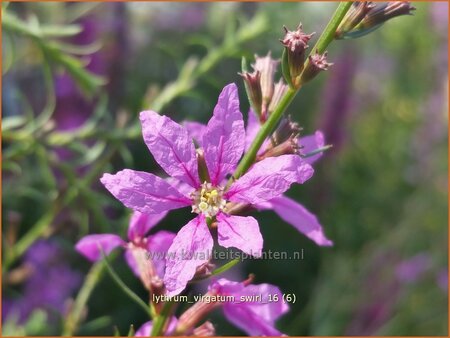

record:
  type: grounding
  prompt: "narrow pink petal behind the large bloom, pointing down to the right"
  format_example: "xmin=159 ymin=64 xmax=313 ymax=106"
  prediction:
xmin=257 ymin=196 xmax=333 ymax=246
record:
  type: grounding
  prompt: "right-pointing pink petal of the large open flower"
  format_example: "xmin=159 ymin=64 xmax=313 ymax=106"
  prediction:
xmin=225 ymin=155 xmax=314 ymax=204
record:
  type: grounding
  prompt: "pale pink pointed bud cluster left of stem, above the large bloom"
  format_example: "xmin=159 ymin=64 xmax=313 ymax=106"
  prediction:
xmin=240 ymin=52 xmax=288 ymax=122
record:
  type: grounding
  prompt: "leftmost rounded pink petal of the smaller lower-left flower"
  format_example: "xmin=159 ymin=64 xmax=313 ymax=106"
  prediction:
xmin=75 ymin=234 xmax=125 ymax=262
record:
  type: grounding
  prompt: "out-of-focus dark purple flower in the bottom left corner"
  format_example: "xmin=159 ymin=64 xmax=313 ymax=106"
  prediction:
xmin=2 ymin=240 xmax=81 ymax=322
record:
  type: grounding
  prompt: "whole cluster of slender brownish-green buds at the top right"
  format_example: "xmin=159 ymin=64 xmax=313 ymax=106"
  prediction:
xmin=336 ymin=1 xmax=415 ymax=39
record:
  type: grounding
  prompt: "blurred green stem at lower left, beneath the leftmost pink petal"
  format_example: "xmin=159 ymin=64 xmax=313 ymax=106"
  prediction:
xmin=63 ymin=261 xmax=105 ymax=336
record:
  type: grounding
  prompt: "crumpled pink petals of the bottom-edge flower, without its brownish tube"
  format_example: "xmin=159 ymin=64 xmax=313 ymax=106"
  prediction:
xmin=210 ymin=278 xmax=289 ymax=336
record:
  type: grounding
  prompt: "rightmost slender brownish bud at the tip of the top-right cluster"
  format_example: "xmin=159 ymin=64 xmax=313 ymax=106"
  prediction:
xmin=357 ymin=1 xmax=416 ymax=29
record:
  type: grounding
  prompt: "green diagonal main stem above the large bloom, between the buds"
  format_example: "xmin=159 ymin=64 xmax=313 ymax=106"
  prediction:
xmin=228 ymin=2 xmax=352 ymax=184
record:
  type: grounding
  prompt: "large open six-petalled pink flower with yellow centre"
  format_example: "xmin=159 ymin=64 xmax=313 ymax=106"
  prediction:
xmin=101 ymin=84 xmax=313 ymax=296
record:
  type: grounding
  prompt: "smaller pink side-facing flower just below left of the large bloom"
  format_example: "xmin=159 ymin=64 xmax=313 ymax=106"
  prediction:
xmin=75 ymin=211 xmax=175 ymax=282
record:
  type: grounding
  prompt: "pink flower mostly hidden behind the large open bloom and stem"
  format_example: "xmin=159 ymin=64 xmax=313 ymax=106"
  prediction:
xmin=184 ymin=110 xmax=333 ymax=246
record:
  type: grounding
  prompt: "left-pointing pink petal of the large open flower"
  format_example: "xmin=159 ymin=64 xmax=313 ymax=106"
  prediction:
xmin=100 ymin=169 xmax=191 ymax=214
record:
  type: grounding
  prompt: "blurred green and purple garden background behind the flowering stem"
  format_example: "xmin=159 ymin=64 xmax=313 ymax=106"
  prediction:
xmin=1 ymin=2 xmax=448 ymax=335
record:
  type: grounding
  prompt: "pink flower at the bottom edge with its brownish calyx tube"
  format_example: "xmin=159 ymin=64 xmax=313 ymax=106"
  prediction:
xmin=176 ymin=278 xmax=289 ymax=336
